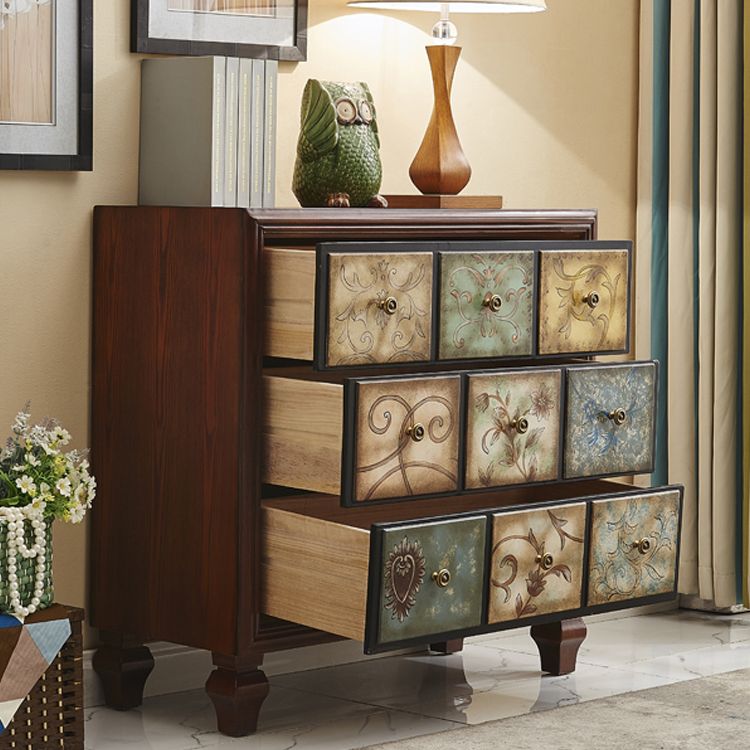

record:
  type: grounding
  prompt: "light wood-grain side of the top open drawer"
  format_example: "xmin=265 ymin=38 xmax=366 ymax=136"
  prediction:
xmin=263 ymin=247 xmax=315 ymax=360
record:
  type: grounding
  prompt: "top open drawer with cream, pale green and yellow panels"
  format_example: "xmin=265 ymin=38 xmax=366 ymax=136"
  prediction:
xmin=264 ymin=241 xmax=632 ymax=369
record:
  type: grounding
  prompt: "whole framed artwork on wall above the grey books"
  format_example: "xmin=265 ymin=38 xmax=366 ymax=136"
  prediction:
xmin=132 ymin=0 xmax=307 ymax=61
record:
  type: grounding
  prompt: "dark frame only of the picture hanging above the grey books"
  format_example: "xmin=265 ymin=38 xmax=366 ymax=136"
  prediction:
xmin=131 ymin=0 xmax=307 ymax=62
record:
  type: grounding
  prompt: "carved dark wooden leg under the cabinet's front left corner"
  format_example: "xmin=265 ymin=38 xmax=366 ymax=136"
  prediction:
xmin=206 ymin=654 xmax=268 ymax=737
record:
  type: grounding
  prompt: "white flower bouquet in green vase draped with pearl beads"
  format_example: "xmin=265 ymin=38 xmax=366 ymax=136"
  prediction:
xmin=0 ymin=404 xmax=96 ymax=617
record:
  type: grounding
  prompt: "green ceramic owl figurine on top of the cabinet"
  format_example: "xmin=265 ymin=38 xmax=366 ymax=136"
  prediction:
xmin=292 ymin=79 xmax=383 ymax=206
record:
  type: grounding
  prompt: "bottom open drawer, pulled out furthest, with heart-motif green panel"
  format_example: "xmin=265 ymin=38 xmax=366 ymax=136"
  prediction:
xmin=262 ymin=480 xmax=682 ymax=653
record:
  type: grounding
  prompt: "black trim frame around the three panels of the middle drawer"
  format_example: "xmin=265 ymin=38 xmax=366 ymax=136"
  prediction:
xmin=341 ymin=359 xmax=659 ymax=508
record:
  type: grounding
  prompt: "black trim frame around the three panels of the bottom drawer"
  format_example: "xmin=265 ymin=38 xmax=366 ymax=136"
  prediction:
xmin=364 ymin=484 xmax=684 ymax=654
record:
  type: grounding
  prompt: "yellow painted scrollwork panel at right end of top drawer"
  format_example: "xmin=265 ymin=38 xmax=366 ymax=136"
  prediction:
xmin=539 ymin=250 xmax=629 ymax=354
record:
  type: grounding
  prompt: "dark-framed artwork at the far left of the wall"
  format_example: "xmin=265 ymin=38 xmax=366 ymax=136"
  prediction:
xmin=0 ymin=0 xmax=93 ymax=171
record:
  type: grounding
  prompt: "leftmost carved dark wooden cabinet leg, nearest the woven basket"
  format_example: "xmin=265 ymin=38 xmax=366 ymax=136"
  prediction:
xmin=93 ymin=632 xmax=154 ymax=711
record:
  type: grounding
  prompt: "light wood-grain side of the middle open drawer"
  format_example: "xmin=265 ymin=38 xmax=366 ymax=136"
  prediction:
xmin=262 ymin=376 xmax=344 ymax=494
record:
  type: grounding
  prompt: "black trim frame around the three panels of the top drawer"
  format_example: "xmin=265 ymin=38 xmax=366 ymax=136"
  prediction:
xmin=313 ymin=240 xmax=633 ymax=372
